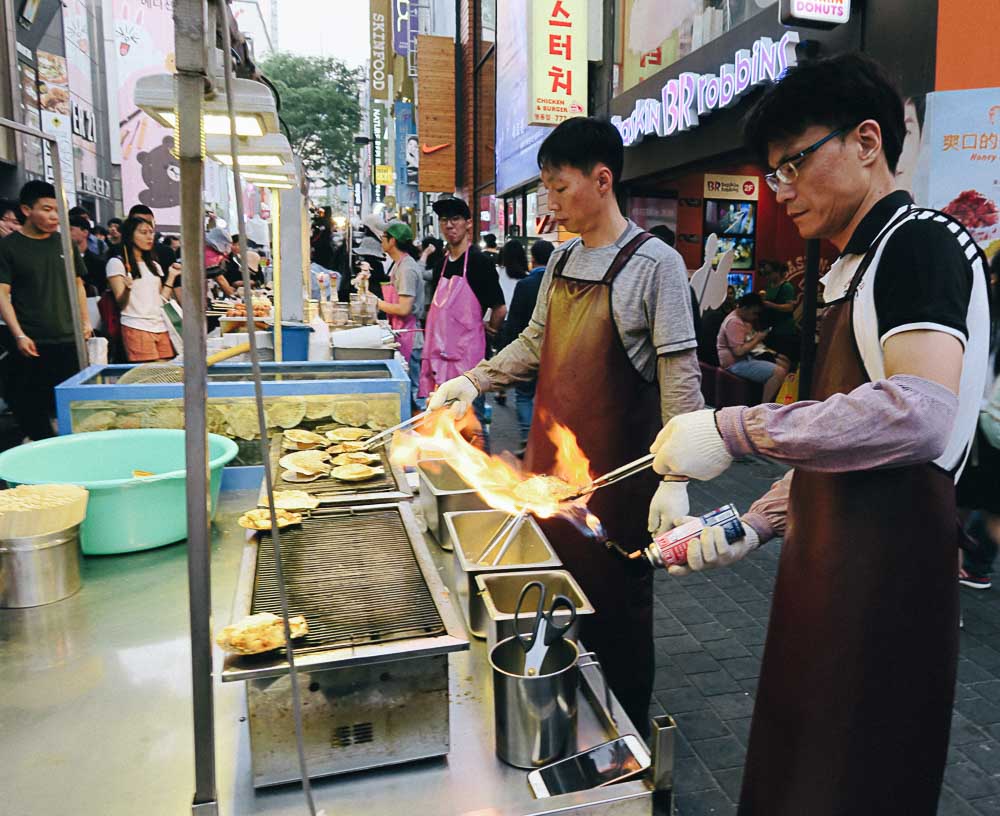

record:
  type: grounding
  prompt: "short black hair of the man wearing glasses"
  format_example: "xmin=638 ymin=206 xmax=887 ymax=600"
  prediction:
xmin=743 ymin=52 xmax=906 ymax=173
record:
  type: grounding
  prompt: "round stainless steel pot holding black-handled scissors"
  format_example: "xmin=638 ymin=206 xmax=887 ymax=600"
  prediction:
xmin=490 ymin=638 xmax=580 ymax=768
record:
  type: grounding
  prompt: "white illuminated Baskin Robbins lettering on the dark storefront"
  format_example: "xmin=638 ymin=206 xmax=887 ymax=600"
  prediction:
xmin=611 ymin=31 xmax=799 ymax=147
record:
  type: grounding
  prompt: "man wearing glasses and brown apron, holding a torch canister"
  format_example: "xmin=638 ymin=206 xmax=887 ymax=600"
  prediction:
xmin=653 ymin=55 xmax=989 ymax=816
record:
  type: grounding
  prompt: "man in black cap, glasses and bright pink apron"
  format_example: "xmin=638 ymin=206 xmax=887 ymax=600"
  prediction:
xmin=420 ymin=197 xmax=507 ymax=404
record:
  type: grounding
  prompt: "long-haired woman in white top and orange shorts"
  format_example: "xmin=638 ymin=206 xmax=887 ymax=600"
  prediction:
xmin=107 ymin=218 xmax=181 ymax=363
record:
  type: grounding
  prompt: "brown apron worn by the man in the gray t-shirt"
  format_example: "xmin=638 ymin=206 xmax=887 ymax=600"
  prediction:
xmin=525 ymin=233 xmax=662 ymax=733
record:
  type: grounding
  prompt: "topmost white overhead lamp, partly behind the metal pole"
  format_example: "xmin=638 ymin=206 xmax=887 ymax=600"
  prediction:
xmin=134 ymin=74 xmax=280 ymax=137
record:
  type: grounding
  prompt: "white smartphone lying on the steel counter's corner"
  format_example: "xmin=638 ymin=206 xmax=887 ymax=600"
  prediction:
xmin=528 ymin=734 xmax=650 ymax=798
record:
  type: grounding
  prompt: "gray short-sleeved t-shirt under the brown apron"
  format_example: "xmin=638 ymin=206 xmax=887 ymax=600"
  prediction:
xmin=531 ymin=221 xmax=698 ymax=382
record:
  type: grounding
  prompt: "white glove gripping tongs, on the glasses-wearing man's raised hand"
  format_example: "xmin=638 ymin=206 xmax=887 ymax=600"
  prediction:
xmin=649 ymin=408 xmax=733 ymax=482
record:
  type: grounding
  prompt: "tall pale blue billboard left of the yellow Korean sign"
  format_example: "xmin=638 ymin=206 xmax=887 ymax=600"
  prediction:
xmin=496 ymin=0 xmax=551 ymax=195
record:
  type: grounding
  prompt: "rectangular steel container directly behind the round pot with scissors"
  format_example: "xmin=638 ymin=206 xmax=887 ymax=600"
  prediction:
xmin=476 ymin=570 xmax=594 ymax=649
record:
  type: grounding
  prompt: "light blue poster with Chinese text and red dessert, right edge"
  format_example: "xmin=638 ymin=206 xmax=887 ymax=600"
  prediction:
xmin=916 ymin=88 xmax=1000 ymax=259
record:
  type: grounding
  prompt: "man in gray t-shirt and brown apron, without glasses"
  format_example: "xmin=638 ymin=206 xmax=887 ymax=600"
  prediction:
xmin=428 ymin=117 xmax=704 ymax=733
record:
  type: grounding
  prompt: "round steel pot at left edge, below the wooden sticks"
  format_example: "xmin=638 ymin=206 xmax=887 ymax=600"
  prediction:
xmin=0 ymin=525 xmax=80 ymax=609
